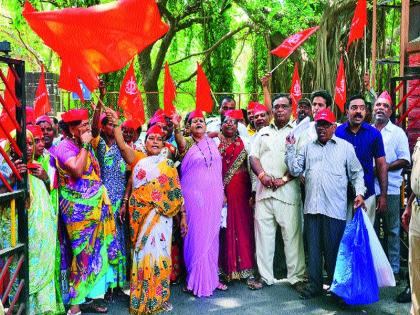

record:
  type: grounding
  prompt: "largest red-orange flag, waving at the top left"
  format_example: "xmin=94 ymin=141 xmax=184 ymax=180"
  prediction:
xmin=22 ymin=0 xmax=169 ymax=99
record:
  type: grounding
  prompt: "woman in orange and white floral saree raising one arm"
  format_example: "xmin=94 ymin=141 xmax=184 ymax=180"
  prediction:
xmin=108 ymin=110 xmax=187 ymax=314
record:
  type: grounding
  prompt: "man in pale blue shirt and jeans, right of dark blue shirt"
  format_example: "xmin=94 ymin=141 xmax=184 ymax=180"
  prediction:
xmin=373 ymin=91 xmax=410 ymax=278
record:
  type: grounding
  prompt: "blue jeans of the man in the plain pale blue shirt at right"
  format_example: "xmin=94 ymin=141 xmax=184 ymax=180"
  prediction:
xmin=375 ymin=195 xmax=401 ymax=273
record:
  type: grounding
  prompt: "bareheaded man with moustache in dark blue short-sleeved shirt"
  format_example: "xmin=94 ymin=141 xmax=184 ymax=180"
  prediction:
xmin=335 ymin=95 xmax=388 ymax=224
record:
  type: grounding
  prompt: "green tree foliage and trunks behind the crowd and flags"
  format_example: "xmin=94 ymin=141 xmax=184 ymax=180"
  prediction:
xmin=0 ymin=0 xmax=399 ymax=114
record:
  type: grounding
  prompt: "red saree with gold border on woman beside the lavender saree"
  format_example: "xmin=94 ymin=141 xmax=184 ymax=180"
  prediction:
xmin=219 ymin=137 xmax=255 ymax=280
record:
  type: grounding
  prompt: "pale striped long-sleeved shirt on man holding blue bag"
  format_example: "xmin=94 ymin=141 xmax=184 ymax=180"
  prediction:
xmin=286 ymin=136 xmax=366 ymax=220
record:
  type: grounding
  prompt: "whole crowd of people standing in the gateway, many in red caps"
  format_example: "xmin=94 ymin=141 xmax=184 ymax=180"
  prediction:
xmin=0 ymin=77 xmax=420 ymax=314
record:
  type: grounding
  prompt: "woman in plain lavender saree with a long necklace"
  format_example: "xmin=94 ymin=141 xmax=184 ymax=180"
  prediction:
xmin=173 ymin=111 xmax=227 ymax=297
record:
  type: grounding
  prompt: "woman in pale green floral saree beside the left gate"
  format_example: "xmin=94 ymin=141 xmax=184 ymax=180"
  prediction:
xmin=0 ymin=130 xmax=64 ymax=314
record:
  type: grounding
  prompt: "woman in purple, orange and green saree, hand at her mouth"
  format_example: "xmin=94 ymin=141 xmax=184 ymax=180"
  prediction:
xmin=55 ymin=109 xmax=121 ymax=314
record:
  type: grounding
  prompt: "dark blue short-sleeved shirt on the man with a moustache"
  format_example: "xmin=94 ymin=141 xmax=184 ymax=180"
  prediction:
xmin=335 ymin=121 xmax=385 ymax=198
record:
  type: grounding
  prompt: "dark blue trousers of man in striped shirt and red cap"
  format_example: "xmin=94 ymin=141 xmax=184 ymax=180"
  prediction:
xmin=305 ymin=214 xmax=346 ymax=292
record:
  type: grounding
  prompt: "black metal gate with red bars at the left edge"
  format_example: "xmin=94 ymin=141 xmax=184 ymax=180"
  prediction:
xmin=0 ymin=56 xmax=29 ymax=314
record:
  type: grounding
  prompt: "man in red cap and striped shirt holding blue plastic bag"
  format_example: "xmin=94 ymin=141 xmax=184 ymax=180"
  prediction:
xmin=286 ymin=109 xmax=366 ymax=299
